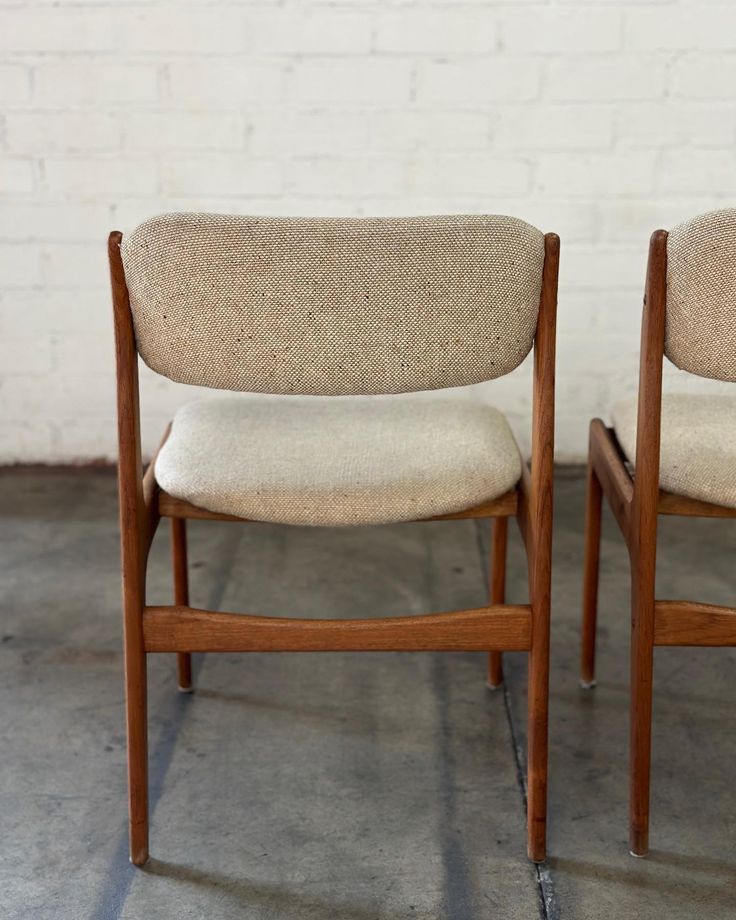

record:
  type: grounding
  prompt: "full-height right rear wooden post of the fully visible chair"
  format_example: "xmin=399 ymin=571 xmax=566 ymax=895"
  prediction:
xmin=522 ymin=233 xmax=560 ymax=862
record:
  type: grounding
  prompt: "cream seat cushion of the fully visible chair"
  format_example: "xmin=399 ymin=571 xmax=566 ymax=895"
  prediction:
xmin=155 ymin=396 xmax=521 ymax=526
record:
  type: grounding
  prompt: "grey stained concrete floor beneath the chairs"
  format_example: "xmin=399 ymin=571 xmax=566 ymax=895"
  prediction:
xmin=0 ymin=472 xmax=736 ymax=920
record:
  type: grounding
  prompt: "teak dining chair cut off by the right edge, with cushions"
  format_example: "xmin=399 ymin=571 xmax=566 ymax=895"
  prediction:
xmin=581 ymin=210 xmax=736 ymax=856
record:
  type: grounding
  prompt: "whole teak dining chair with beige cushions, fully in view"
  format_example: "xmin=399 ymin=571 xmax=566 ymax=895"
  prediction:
xmin=109 ymin=214 xmax=559 ymax=865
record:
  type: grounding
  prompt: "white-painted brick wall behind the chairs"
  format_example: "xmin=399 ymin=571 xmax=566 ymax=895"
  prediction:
xmin=0 ymin=0 xmax=736 ymax=462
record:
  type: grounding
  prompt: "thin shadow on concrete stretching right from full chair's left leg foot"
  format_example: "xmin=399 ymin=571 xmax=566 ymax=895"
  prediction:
xmin=142 ymin=858 xmax=434 ymax=920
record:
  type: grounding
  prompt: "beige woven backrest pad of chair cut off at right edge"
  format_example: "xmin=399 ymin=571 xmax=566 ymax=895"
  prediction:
xmin=665 ymin=208 xmax=736 ymax=380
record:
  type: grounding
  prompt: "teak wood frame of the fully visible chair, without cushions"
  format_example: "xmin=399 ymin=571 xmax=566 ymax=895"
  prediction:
xmin=108 ymin=232 xmax=559 ymax=866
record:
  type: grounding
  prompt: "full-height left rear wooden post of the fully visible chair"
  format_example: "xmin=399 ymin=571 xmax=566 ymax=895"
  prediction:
xmin=108 ymin=232 xmax=148 ymax=865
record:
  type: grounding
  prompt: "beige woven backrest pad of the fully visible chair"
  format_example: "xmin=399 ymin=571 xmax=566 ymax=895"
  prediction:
xmin=121 ymin=214 xmax=544 ymax=395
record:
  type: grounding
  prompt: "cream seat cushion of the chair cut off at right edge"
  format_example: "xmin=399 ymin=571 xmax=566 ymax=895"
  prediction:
xmin=613 ymin=393 xmax=736 ymax=508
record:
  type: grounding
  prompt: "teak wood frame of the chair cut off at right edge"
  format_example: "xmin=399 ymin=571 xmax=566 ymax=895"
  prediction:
xmin=581 ymin=230 xmax=736 ymax=856
